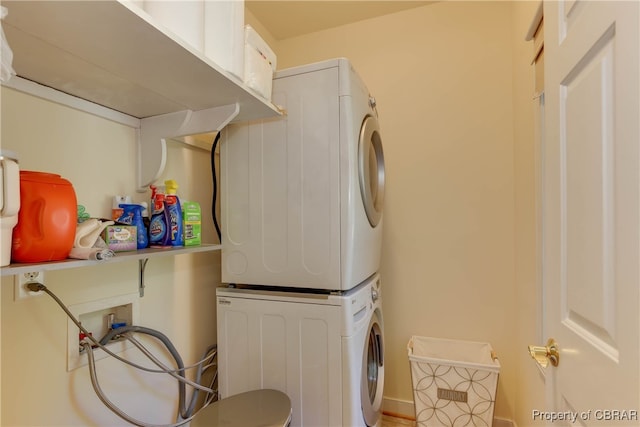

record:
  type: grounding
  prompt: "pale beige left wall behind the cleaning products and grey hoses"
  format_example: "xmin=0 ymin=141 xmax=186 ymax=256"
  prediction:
xmin=1 ymin=87 xmax=220 ymax=426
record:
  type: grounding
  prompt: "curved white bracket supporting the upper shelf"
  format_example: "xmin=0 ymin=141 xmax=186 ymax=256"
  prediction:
xmin=137 ymin=102 xmax=240 ymax=193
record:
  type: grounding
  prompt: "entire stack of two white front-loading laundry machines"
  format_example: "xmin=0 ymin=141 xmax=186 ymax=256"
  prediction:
xmin=217 ymin=58 xmax=384 ymax=426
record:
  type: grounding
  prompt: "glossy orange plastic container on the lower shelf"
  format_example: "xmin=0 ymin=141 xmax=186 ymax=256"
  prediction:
xmin=11 ymin=171 xmax=78 ymax=262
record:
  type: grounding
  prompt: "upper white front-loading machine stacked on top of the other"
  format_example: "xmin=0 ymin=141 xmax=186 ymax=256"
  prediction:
xmin=220 ymin=59 xmax=384 ymax=290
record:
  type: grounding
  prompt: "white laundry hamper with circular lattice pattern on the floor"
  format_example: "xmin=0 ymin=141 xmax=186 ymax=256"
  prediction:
xmin=407 ymin=336 xmax=500 ymax=427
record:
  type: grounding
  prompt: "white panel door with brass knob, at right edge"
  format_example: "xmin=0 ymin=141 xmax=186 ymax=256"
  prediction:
xmin=543 ymin=1 xmax=640 ymax=426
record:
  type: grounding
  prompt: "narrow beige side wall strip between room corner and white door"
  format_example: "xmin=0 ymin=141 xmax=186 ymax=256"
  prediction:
xmin=513 ymin=1 xmax=546 ymax=427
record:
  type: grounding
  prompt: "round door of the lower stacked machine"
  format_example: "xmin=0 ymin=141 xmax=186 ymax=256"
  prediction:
xmin=360 ymin=311 xmax=384 ymax=426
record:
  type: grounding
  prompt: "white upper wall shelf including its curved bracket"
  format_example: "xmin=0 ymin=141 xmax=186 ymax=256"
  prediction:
xmin=2 ymin=0 xmax=281 ymax=190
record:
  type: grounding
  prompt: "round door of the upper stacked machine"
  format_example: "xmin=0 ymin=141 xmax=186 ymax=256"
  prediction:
xmin=358 ymin=116 xmax=384 ymax=227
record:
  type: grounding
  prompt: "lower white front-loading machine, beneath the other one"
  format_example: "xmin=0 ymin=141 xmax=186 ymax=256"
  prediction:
xmin=217 ymin=275 xmax=384 ymax=427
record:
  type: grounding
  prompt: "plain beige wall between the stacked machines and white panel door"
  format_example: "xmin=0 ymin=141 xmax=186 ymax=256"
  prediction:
xmin=275 ymin=2 xmax=543 ymax=426
